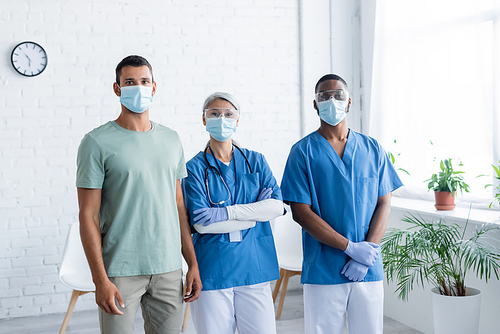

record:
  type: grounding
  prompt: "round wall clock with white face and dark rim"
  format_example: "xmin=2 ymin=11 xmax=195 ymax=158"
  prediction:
xmin=11 ymin=42 xmax=47 ymax=77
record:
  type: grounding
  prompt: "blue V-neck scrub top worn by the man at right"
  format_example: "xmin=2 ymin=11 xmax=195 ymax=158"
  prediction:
xmin=281 ymin=130 xmax=403 ymax=284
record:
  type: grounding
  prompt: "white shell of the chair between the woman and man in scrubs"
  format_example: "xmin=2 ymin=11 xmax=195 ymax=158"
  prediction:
xmin=273 ymin=206 xmax=302 ymax=270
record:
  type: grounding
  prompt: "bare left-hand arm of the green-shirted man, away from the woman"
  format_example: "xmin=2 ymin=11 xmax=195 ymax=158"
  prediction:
xmin=77 ymin=188 xmax=125 ymax=315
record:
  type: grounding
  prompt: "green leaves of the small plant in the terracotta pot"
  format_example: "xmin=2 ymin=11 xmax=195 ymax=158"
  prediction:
xmin=424 ymin=158 xmax=469 ymax=196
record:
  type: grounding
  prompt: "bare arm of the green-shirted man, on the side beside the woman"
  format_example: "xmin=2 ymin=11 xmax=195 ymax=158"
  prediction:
xmin=175 ymin=180 xmax=202 ymax=302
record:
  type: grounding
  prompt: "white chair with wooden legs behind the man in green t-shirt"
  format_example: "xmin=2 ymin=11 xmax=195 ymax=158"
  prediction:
xmin=59 ymin=223 xmax=95 ymax=334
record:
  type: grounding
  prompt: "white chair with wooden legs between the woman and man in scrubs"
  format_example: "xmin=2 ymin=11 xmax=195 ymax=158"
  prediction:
xmin=273 ymin=206 xmax=302 ymax=319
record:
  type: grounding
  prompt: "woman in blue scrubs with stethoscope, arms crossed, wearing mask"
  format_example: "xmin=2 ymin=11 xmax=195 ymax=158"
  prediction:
xmin=182 ymin=92 xmax=283 ymax=334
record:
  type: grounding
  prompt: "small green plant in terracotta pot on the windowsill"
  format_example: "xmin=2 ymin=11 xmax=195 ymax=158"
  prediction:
xmin=424 ymin=158 xmax=469 ymax=210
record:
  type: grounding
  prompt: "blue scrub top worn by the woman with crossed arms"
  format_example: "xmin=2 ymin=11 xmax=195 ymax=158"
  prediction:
xmin=182 ymin=148 xmax=283 ymax=290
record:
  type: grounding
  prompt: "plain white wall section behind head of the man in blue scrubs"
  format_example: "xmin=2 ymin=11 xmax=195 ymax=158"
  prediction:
xmin=301 ymin=0 xmax=363 ymax=135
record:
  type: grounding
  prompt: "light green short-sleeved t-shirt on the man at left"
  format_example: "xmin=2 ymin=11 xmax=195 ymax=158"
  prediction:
xmin=76 ymin=121 xmax=187 ymax=277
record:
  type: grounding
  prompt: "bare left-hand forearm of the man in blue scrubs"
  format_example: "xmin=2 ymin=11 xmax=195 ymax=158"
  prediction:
xmin=290 ymin=202 xmax=349 ymax=251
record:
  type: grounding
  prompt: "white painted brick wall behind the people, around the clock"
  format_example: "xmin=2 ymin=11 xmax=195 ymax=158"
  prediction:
xmin=0 ymin=0 xmax=300 ymax=319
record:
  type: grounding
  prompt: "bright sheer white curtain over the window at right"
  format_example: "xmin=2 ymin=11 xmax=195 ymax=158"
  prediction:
xmin=369 ymin=0 xmax=500 ymax=203
